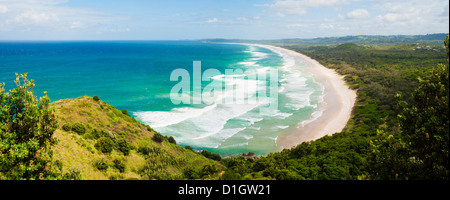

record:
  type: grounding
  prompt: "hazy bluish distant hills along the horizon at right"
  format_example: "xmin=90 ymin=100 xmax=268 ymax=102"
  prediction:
xmin=202 ymin=33 xmax=448 ymax=45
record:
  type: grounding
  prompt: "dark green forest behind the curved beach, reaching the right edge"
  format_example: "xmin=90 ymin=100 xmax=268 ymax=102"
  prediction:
xmin=218 ymin=36 xmax=449 ymax=180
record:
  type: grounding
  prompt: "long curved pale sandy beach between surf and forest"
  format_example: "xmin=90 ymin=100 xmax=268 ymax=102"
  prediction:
xmin=253 ymin=44 xmax=356 ymax=151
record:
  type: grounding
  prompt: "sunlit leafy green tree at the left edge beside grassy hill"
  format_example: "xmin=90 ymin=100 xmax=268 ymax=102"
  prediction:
xmin=0 ymin=73 xmax=79 ymax=180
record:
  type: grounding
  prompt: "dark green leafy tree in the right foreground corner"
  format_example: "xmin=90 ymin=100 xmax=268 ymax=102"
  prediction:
xmin=369 ymin=36 xmax=449 ymax=180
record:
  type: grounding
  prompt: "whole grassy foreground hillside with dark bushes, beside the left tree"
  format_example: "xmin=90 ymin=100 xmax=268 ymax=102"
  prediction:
xmin=51 ymin=96 xmax=224 ymax=180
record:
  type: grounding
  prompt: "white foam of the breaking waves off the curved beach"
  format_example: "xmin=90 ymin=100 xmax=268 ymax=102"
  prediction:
xmin=134 ymin=42 xmax=323 ymax=153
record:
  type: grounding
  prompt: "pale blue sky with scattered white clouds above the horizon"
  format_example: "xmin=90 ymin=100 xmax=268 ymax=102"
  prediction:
xmin=0 ymin=0 xmax=449 ymax=40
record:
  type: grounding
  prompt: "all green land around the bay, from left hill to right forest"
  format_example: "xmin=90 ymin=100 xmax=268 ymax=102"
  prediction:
xmin=0 ymin=36 xmax=449 ymax=180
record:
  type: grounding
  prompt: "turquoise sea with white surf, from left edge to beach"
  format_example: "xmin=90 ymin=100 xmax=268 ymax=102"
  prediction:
xmin=0 ymin=41 xmax=323 ymax=155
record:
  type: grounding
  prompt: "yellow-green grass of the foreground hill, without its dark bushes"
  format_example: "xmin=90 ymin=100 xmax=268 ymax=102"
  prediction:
xmin=52 ymin=96 xmax=222 ymax=180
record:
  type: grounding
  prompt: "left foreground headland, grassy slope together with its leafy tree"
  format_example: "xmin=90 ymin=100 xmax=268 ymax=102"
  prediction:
xmin=0 ymin=78 xmax=224 ymax=180
